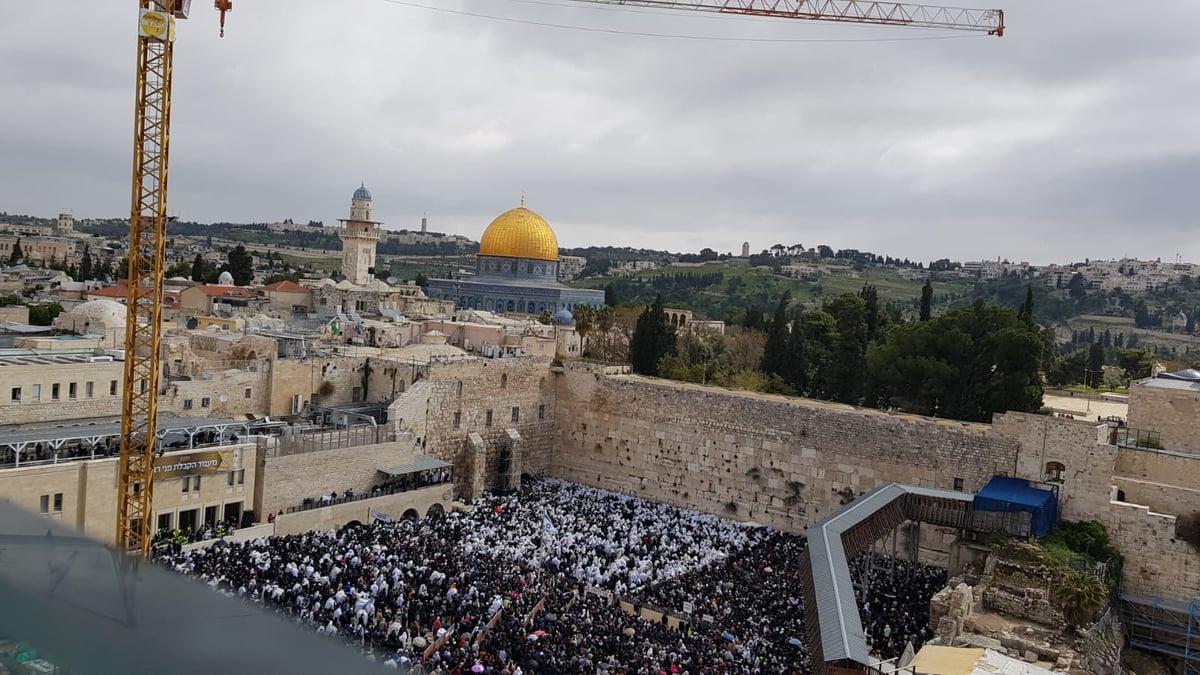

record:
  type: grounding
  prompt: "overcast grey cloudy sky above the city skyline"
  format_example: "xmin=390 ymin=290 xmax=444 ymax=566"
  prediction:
xmin=0 ymin=0 xmax=1200 ymax=264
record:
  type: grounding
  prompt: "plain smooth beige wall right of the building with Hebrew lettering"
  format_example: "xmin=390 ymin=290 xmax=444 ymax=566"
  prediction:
xmin=257 ymin=441 xmax=414 ymax=518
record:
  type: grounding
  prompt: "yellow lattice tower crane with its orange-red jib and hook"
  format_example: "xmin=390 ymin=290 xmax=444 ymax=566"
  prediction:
xmin=116 ymin=0 xmax=1004 ymax=556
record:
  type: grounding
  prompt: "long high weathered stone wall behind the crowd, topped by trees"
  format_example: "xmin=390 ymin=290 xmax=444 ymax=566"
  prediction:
xmin=550 ymin=363 xmax=1018 ymax=532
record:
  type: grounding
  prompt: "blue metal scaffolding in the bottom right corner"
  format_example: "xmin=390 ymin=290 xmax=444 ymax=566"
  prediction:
xmin=1120 ymin=593 xmax=1200 ymax=675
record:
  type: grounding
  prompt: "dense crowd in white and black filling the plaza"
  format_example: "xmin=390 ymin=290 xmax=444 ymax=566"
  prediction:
xmin=158 ymin=480 xmax=944 ymax=674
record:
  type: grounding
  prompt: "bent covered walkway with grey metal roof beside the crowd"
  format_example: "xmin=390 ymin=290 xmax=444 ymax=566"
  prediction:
xmin=800 ymin=483 xmax=973 ymax=673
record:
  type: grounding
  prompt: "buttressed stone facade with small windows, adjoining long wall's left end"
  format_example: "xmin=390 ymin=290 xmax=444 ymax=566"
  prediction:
xmin=388 ymin=357 xmax=556 ymax=494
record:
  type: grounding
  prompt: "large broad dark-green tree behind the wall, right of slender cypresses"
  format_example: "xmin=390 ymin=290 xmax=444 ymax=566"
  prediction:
xmin=866 ymin=300 xmax=1043 ymax=422
